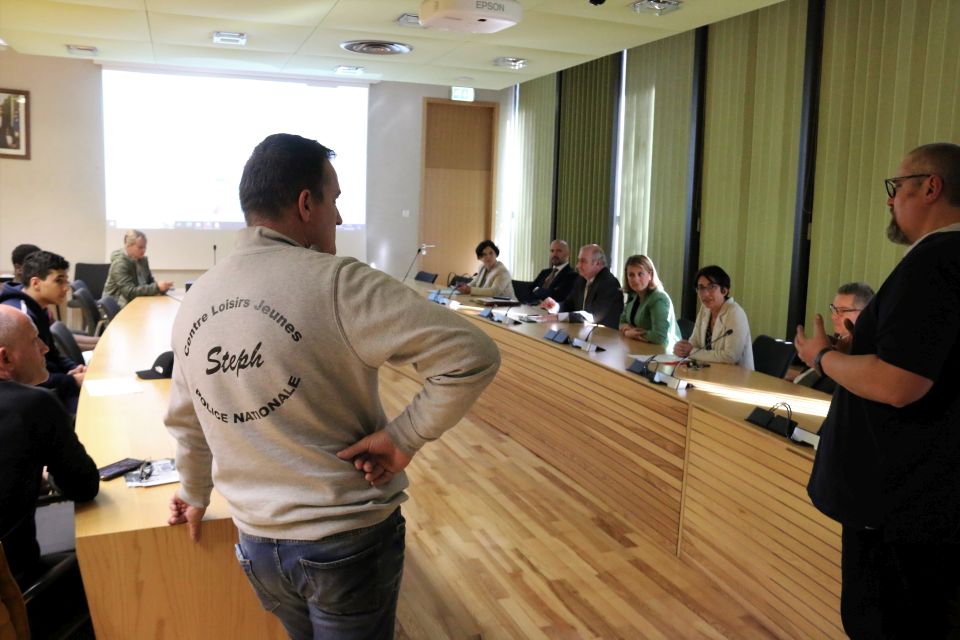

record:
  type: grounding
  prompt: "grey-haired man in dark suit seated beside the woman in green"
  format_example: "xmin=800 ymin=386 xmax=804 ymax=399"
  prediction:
xmin=540 ymin=244 xmax=623 ymax=329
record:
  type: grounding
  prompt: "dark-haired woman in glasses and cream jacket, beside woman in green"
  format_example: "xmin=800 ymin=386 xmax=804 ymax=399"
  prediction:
xmin=673 ymin=265 xmax=753 ymax=370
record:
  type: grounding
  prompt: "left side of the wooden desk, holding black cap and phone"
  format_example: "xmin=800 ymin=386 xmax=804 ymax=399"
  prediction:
xmin=76 ymin=296 xmax=286 ymax=640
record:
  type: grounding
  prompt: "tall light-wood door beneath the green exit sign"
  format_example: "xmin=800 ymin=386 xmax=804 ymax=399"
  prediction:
xmin=420 ymin=98 xmax=499 ymax=283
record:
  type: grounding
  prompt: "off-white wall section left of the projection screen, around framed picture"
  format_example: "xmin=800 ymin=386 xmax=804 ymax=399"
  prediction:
xmin=0 ymin=50 xmax=106 ymax=273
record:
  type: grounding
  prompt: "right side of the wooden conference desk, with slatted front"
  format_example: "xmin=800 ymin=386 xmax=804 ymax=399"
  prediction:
xmin=405 ymin=287 xmax=844 ymax=638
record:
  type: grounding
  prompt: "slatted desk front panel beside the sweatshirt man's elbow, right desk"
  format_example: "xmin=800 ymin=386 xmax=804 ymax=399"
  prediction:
xmin=470 ymin=319 xmax=687 ymax=550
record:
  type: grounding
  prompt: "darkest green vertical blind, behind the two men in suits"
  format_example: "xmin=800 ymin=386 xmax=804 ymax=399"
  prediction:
xmin=557 ymin=54 xmax=621 ymax=259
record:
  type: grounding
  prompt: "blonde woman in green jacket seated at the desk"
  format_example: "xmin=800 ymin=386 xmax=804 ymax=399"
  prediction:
xmin=620 ymin=256 xmax=680 ymax=351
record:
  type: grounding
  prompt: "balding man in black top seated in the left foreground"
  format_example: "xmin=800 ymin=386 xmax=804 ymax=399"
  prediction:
xmin=0 ymin=305 xmax=100 ymax=585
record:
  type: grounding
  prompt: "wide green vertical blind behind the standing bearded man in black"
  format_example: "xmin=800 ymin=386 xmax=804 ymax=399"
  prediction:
xmin=807 ymin=0 xmax=960 ymax=330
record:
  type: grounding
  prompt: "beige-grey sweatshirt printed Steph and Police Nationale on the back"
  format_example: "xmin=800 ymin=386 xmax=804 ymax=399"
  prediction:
xmin=166 ymin=227 xmax=500 ymax=540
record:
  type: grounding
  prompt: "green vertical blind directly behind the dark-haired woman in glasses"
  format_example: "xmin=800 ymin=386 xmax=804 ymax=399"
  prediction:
xmin=700 ymin=0 xmax=807 ymax=337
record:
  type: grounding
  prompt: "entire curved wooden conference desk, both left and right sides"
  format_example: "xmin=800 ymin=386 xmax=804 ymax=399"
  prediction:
xmin=77 ymin=297 xmax=843 ymax=639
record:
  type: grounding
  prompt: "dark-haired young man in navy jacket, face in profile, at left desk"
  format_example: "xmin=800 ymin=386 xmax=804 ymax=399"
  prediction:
xmin=0 ymin=251 xmax=87 ymax=413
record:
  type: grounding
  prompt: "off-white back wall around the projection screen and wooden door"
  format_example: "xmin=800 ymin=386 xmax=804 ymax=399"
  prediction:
xmin=0 ymin=50 xmax=507 ymax=286
